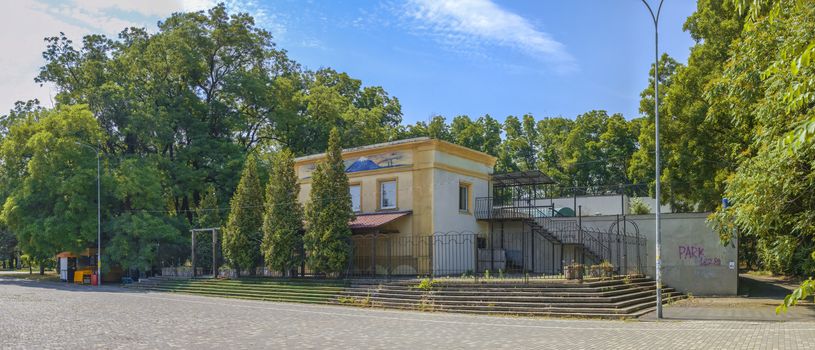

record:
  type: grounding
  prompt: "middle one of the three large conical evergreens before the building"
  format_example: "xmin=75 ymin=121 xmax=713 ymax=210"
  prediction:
xmin=263 ymin=149 xmax=303 ymax=275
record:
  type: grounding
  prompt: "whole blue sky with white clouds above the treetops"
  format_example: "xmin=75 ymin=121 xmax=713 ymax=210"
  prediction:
xmin=0 ymin=0 xmax=696 ymax=124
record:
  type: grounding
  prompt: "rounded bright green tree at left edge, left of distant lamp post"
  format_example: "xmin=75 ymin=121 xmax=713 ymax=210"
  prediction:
xmin=0 ymin=106 xmax=105 ymax=261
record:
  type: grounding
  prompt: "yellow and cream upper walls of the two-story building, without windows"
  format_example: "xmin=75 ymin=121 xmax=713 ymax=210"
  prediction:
xmin=295 ymin=139 xmax=495 ymax=241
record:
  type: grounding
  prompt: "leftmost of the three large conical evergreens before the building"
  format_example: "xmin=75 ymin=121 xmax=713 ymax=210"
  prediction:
xmin=223 ymin=154 xmax=263 ymax=274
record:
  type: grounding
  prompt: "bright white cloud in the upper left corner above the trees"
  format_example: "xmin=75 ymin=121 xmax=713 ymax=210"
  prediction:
xmin=0 ymin=0 xmax=285 ymax=115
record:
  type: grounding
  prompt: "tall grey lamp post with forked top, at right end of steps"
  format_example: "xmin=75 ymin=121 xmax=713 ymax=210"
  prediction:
xmin=641 ymin=0 xmax=664 ymax=319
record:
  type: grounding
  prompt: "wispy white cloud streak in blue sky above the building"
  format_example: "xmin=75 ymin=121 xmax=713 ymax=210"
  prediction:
xmin=401 ymin=0 xmax=575 ymax=71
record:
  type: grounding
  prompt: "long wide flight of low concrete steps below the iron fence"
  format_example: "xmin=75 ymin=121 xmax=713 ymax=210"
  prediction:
xmin=122 ymin=277 xmax=684 ymax=319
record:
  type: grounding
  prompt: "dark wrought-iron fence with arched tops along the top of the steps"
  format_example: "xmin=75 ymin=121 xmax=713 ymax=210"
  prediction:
xmin=185 ymin=226 xmax=646 ymax=279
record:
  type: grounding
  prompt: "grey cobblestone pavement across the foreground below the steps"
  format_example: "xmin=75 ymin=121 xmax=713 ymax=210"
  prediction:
xmin=0 ymin=277 xmax=815 ymax=350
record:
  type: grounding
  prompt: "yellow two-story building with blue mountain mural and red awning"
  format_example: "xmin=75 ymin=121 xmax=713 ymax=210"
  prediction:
xmin=295 ymin=138 xmax=496 ymax=274
